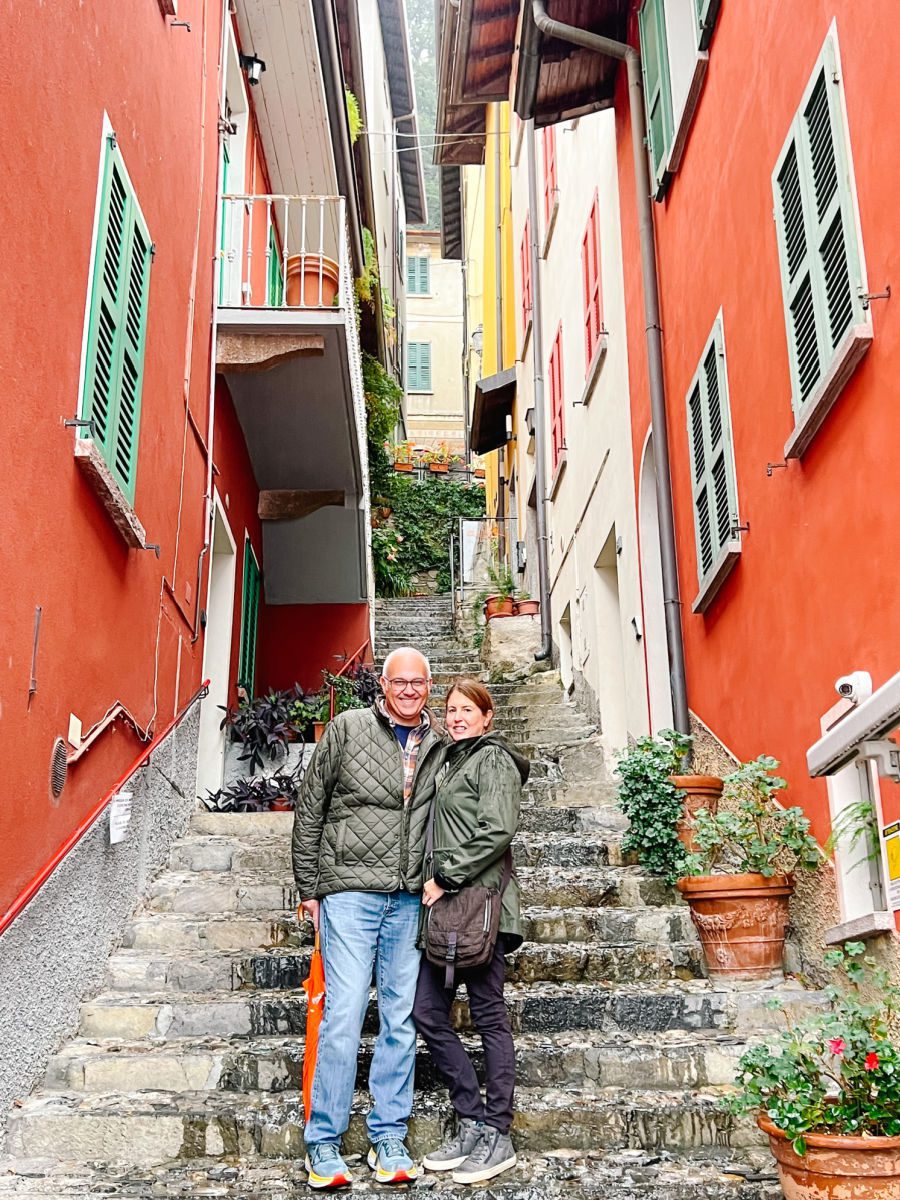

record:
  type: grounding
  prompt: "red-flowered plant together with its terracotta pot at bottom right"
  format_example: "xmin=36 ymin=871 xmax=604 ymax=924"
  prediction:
xmin=725 ymin=942 xmax=900 ymax=1200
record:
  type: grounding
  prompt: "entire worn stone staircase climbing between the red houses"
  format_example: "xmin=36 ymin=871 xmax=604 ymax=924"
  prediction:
xmin=0 ymin=598 xmax=821 ymax=1200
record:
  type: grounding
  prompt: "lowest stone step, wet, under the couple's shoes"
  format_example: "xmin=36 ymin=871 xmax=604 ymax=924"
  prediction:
xmin=0 ymin=1150 xmax=782 ymax=1200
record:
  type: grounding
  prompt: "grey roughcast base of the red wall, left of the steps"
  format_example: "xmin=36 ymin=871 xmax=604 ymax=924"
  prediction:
xmin=0 ymin=706 xmax=199 ymax=1145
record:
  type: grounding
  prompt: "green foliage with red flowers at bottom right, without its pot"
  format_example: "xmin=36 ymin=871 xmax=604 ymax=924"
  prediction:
xmin=722 ymin=942 xmax=900 ymax=1154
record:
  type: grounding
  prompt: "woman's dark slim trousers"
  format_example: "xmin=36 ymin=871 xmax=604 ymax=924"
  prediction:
xmin=413 ymin=938 xmax=516 ymax=1133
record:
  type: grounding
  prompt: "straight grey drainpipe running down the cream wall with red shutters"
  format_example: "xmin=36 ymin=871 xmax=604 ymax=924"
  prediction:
xmin=526 ymin=119 xmax=553 ymax=662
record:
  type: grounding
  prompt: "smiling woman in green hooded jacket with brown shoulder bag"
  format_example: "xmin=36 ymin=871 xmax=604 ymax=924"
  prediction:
xmin=413 ymin=678 xmax=529 ymax=1183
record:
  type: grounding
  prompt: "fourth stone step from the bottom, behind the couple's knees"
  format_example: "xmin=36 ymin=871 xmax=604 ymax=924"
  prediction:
xmin=79 ymin=979 xmax=824 ymax=1042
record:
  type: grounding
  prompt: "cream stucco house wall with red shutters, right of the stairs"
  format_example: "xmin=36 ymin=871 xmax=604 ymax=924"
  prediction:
xmin=512 ymin=112 xmax=648 ymax=750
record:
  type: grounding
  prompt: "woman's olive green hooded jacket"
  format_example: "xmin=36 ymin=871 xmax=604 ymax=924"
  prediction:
xmin=425 ymin=733 xmax=530 ymax=953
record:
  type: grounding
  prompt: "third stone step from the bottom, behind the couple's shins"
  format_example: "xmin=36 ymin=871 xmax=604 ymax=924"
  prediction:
xmin=44 ymin=1031 xmax=748 ymax=1094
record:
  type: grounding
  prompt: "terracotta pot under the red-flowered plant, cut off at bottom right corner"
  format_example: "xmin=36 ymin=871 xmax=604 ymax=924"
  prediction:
xmin=758 ymin=1116 xmax=900 ymax=1200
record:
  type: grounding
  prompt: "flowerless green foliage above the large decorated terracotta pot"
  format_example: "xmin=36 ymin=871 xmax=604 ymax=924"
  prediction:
xmin=684 ymin=755 xmax=822 ymax=878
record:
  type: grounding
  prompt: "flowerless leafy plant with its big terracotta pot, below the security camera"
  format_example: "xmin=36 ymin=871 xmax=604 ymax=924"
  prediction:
xmin=678 ymin=755 xmax=821 ymax=979
